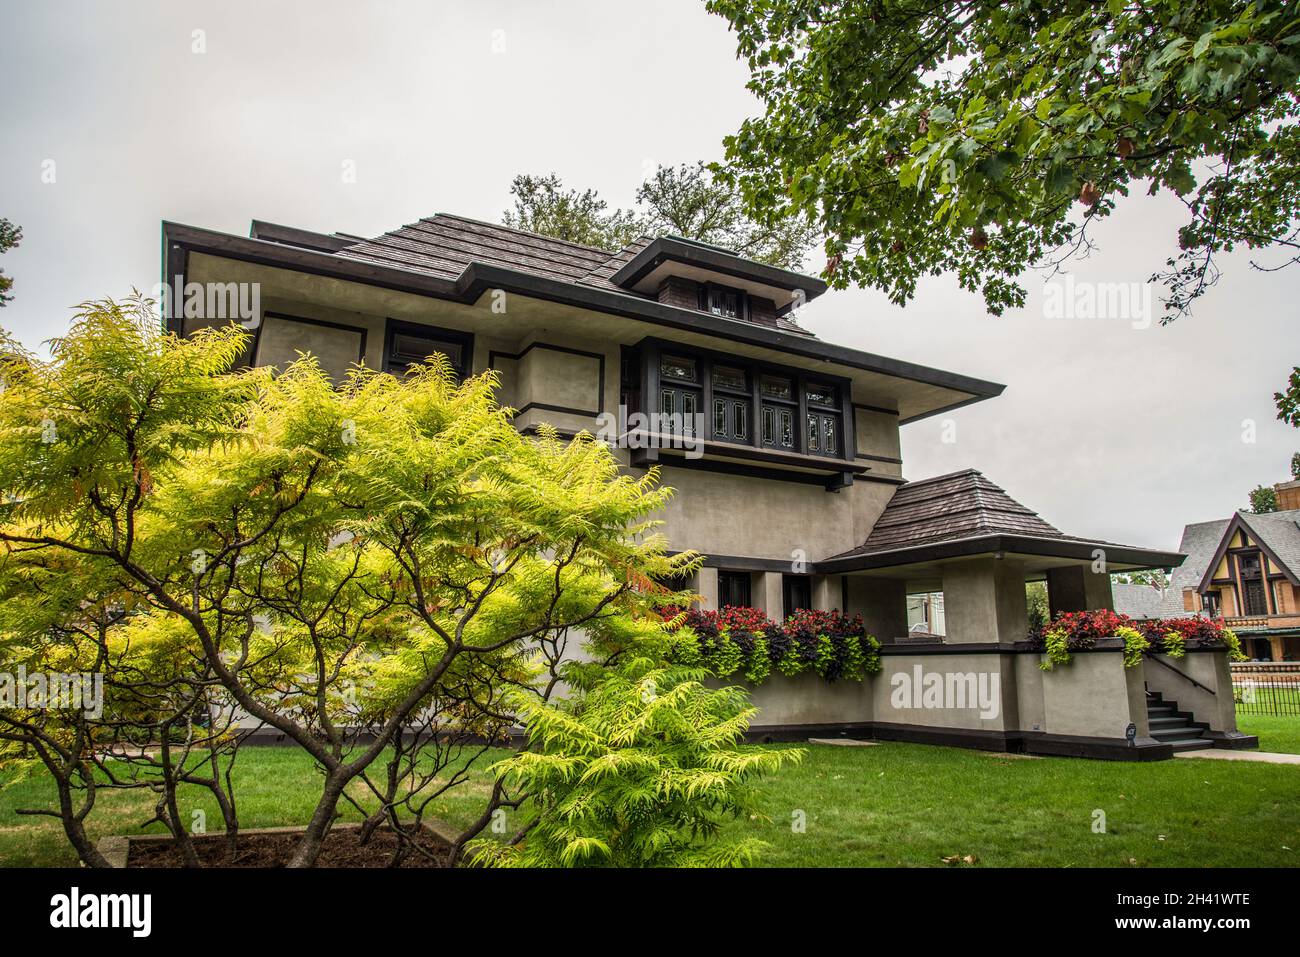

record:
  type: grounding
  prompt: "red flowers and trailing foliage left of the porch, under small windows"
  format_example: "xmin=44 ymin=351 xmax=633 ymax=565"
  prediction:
xmin=675 ymin=606 xmax=880 ymax=684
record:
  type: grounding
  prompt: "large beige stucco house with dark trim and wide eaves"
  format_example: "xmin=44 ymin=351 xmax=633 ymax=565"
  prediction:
xmin=163 ymin=213 xmax=1235 ymax=758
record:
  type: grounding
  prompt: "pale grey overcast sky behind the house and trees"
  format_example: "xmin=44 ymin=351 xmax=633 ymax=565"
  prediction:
xmin=0 ymin=0 xmax=1300 ymax=547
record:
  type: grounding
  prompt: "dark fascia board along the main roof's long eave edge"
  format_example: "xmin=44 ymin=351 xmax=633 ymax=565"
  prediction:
xmin=154 ymin=221 xmax=1006 ymax=421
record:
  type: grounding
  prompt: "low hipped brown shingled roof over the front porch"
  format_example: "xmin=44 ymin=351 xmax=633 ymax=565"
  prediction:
xmin=818 ymin=468 xmax=1182 ymax=571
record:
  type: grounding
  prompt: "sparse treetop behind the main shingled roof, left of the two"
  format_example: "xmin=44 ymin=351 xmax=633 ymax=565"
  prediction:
xmin=502 ymin=173 xmax=644 ymax=250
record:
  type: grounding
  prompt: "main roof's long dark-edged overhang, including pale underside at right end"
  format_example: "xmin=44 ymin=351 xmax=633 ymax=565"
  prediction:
xmin=163 ymin=221 xmax=1006 ymax=425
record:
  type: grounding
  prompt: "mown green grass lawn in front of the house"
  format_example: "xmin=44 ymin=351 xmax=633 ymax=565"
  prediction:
xmin=0 ymin=733 xmax=1300 ymax=867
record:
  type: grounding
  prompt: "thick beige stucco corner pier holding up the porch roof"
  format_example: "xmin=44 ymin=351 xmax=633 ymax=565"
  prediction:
xmin=944 ymin=557 xmax=1030 ymax=645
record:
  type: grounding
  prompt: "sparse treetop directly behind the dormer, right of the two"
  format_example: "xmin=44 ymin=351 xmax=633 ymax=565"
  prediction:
xmin=637 ymin=163 xmax=818 ymax=269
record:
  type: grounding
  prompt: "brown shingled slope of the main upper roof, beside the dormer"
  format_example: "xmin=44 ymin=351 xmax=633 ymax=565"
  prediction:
xmin=334 ymin=213 xmax=813 ymax=337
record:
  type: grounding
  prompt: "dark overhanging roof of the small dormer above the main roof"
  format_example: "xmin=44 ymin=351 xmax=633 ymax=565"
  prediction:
xmin=610 ymin=235 xmax=827 ymax=315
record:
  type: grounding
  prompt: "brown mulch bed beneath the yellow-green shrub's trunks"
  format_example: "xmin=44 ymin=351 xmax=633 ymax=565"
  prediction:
xmin=126 ymin=827 xmax=449 ymax=867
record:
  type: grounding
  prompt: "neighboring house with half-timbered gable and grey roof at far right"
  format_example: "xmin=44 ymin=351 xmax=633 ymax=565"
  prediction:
xmin=1138 ymin=481 xmax=1300 ymax=662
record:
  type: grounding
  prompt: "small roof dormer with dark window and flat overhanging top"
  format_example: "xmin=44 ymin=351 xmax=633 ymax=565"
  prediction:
xmin=610 ymin=235 xmax=827 ymax=335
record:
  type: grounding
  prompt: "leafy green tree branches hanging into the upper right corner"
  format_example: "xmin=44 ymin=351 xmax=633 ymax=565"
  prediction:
xmin=709 ymin=0 xmax=1300 ymax=321
